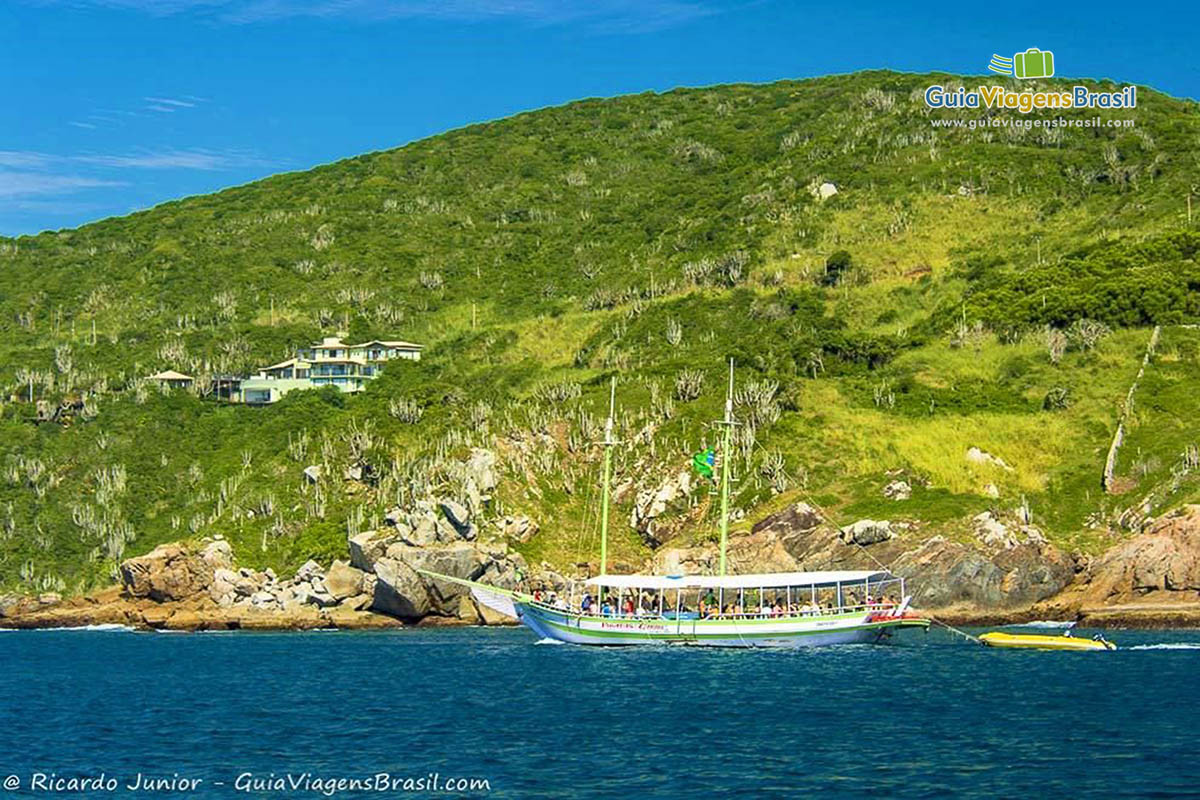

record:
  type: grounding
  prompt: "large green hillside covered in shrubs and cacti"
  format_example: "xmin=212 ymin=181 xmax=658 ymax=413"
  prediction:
xmin=0 ymin=72 xmax=1200 ymax=590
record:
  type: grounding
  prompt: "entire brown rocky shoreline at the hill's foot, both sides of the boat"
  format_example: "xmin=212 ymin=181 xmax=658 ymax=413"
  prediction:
xmin=7 ymin=503 xmax=1200 ymax=631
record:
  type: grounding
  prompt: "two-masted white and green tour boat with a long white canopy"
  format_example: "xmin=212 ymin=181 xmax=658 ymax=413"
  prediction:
xmin=422 ymin=362 xmax=930 ymax=648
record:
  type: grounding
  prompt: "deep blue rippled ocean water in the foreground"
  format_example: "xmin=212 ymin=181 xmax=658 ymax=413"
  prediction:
xmin=0 ymin=628 xmax=1200 ymax=798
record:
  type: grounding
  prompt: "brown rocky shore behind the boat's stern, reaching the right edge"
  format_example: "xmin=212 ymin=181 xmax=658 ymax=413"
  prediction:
xmin=739 ymin=504 xmax=1200 ymax=627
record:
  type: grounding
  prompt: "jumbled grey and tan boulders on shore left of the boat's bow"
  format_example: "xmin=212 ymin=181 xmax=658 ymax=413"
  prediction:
xmin=0 ymin=510 xmax=530 ymax=630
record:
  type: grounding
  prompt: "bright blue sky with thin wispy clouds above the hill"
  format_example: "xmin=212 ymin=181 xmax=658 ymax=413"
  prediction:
xmin=0 ymin=0 xmax=1200 ymax=235
